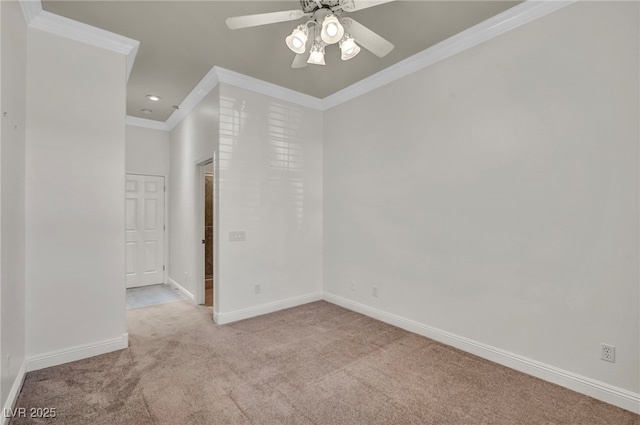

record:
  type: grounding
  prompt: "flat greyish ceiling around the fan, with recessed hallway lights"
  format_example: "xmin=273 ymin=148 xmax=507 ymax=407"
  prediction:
xmin=42 ymin=0 xmax=520 ymax=121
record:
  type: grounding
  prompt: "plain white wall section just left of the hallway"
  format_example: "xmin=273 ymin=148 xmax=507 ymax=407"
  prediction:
xmin=26 ymin=28 xmax=126 ymax=362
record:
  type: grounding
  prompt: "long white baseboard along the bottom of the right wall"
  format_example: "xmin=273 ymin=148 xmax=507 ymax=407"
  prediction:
xmin=324 ymin=292 xmax=640 ymax=413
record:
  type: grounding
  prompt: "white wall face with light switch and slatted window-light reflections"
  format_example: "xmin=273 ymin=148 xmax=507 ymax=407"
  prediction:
xmin=217 ymin=84 xmax=322 ymax=322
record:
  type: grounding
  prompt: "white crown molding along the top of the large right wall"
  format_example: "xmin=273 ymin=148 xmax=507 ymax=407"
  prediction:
xmin=322 ymin=0 xmax=578 ymax=111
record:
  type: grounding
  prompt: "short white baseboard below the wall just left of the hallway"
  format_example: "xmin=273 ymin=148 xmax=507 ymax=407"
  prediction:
xmin=27 ymin=333 xmax=129 ymax=372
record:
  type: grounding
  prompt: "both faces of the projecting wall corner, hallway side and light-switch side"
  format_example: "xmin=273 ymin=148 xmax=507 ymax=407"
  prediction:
xmin=169 ymin=84 xmax=322 ymax=323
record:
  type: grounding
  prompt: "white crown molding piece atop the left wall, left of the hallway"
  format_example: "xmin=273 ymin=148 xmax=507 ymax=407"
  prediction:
xmin=20 ymin=0 xmax=140 ymax=80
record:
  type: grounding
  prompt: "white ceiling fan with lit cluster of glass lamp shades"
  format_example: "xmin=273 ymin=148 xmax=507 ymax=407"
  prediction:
xmin=226 ymin=0 xmax=394 ymax=68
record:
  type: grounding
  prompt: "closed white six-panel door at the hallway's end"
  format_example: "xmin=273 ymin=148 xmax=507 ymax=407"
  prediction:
xmin=125 ymin=174 xmax=165 ymax=288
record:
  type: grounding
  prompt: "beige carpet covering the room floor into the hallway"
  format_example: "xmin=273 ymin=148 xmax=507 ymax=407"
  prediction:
xmin=11 ymin=301 xmax=640 ymax=425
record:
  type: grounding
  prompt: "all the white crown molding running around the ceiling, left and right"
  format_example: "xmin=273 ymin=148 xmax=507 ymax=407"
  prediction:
xmin=43 ymin=0 xmax=578 ymax=131
